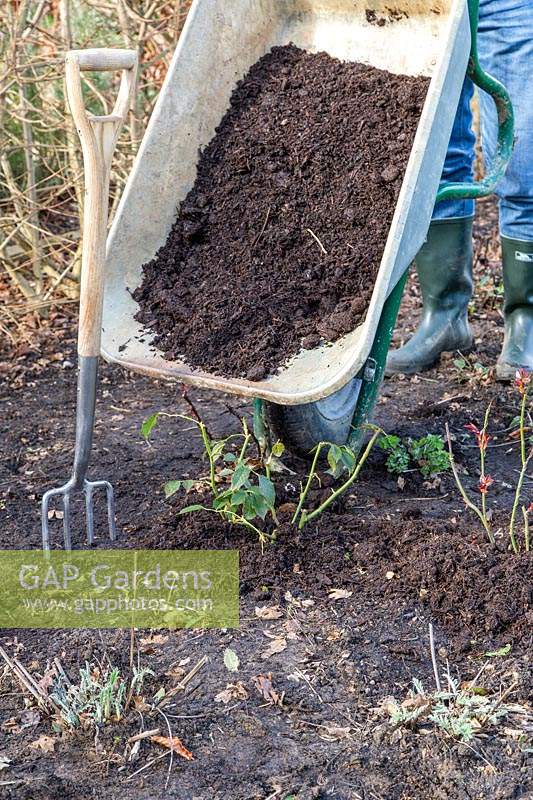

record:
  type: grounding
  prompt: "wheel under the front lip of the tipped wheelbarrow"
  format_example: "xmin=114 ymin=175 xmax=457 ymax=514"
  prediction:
xmin=265 ymin=378 xmax=361 ymax=458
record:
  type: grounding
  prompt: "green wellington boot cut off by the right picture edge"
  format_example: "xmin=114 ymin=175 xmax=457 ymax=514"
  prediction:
xmin=496 ymin=236 xmax=533 ymax=380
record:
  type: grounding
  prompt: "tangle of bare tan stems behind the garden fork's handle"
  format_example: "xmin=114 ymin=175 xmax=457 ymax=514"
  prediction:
xmin=0 ymin=0 xmax=191 ymax=336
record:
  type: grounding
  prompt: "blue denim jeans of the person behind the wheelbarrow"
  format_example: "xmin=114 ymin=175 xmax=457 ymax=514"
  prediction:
xmin=433 ymin=0 xmax=533 ymax=241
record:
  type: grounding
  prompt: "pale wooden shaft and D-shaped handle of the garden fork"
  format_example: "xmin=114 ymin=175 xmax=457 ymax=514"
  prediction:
xmin=65 ymin=49 xmax=138 ymax=356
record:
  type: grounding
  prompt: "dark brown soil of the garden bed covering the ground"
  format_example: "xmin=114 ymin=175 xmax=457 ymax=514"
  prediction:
xmin=0 ymin=204 xmax=533 ymax=800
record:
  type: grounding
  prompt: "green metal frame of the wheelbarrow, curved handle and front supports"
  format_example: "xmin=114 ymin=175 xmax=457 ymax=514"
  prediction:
xmin=254 ymin=0 xmax=514 ymax=451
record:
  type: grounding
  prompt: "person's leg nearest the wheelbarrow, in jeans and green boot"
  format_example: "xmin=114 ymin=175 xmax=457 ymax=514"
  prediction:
xmin=386 ymin=79 xmax=475 ymax=375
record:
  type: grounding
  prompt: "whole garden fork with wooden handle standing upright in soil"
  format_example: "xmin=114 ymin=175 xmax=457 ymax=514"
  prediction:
xmin=41 ymin=49 xmax=137 ymax=550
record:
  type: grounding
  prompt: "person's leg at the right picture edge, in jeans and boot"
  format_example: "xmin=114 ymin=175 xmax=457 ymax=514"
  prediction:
xmin=479 ymin=0 xmax=533 ymax=379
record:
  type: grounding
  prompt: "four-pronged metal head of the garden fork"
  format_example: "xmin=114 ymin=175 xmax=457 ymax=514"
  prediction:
xmin=41 ymin=479 xmax=117 ymax=550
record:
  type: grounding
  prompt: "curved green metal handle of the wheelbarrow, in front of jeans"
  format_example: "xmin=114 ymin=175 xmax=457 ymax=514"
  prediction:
xmin=435 ymin=0 xmax=514 ymax=203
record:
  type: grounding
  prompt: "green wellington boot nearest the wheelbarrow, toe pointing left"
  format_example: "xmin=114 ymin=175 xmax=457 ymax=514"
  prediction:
xmin=385 ymin=217 xmax=473 ymax=376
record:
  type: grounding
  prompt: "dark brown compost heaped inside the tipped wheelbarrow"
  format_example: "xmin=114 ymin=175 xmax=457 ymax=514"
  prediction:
xmin=133 ymin=44 xmax=428 ymax=380
